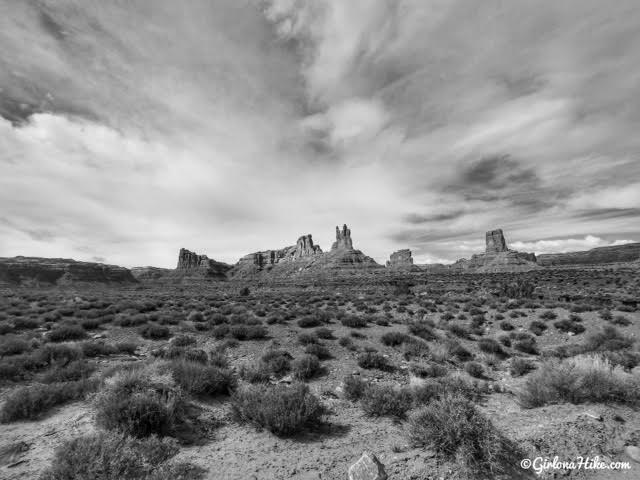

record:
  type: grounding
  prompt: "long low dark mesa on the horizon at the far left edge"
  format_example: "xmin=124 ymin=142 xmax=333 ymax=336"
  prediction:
xmin=0 ymin=257 xmax=136 ymax=285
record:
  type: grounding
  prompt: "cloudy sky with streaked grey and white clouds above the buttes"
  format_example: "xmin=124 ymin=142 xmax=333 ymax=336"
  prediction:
xmin=0 ymin=0 xmax=640 ymax=267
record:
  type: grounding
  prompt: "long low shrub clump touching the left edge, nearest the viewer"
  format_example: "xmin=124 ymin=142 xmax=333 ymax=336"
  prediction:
xmin=0 ymin=380 xmax=98 ymax=423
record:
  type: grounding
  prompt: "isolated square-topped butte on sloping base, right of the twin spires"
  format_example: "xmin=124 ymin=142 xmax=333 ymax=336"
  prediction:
xmin=449 ymin=229 xmax=540 ymax=273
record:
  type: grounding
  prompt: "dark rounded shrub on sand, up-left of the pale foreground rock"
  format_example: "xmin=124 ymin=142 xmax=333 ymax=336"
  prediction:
xmin=231 ymin=383 xmax=325 ymax=436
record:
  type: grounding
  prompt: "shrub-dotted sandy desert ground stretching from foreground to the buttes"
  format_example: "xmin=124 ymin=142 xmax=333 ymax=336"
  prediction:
xmin=0 ymin=266 xmax=640 ymax=480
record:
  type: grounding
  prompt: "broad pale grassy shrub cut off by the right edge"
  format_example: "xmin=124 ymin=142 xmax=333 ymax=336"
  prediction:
xmin=519 ymin=355 xmax=640 ymax=408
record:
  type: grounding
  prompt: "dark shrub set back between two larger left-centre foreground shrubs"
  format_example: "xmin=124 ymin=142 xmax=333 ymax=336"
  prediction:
xmin=170 ymin=360 xmax=236 ymax=396
